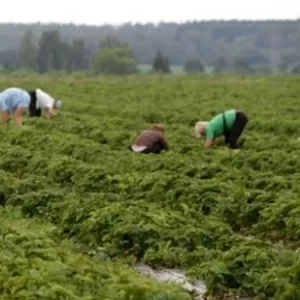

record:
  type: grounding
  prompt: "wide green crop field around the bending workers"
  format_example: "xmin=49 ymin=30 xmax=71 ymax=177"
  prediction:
xmin=0 ymin=76 xmax=300 ymax=300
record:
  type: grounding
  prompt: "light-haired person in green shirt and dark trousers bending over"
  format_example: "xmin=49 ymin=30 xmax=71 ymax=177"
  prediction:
xmin=195 ymin=109 xmax=248 ymax=149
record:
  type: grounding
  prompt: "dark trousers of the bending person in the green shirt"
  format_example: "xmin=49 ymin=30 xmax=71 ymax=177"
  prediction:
xmin=225 ymin=111 xmax=248 ymax=149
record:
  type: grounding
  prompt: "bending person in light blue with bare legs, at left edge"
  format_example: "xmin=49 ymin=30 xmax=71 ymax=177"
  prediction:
xmin=0 ymin=87 xmax=30 ymax=126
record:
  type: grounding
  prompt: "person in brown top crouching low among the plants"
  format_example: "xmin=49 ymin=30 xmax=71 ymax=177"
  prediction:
xmin=130 ymin=125 xmax=169 ymax=154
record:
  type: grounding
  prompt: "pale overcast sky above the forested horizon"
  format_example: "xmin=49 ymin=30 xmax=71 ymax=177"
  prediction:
xmin=0 ymin=0 xmax=300 ymax=25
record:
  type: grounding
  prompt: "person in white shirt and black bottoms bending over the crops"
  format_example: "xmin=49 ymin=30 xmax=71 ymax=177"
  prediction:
xmin=28 ymin=89 xmax=62 ymax=119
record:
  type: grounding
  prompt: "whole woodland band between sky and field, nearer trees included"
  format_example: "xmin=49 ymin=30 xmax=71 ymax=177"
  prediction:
xmin=0 ymin=20 xmax=300 ymax=73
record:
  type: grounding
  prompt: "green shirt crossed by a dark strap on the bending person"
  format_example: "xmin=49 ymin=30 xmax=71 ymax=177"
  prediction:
xmin=206 ymin=109 xmax=236 ymax=140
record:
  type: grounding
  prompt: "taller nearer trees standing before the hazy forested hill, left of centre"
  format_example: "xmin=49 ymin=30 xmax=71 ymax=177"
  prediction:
xmin=14 ymin=30 xmax=170 ymax=75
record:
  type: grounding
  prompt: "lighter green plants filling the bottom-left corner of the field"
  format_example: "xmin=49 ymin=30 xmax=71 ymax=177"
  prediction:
xmin=0 ymin=209 xmax=190 ymax=300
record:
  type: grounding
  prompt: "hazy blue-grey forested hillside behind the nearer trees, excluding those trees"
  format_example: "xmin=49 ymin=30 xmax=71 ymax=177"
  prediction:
xmin=0 ymin=20 xmax=300 ymax=71
